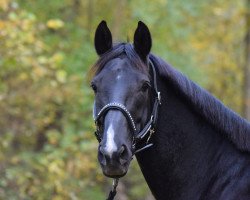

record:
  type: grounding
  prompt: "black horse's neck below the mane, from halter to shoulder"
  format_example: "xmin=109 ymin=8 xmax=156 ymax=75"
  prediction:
xmin=137 ymin=75 xmax=245 ymax=199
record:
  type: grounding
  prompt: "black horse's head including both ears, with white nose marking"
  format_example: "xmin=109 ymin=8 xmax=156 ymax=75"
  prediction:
xmin=91 ymin=21 xmax=154 ymax=178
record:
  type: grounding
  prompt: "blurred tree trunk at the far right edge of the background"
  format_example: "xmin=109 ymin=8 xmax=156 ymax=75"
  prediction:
xmin=243 ymin=0 xmax=250 ymax=120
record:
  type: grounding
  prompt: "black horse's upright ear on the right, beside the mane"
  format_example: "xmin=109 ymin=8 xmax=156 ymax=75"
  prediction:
xmin=134 ymin=21 xmax=152 ymax=61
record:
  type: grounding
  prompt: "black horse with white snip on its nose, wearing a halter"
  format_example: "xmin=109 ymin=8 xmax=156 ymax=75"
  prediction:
xmin=91 ymin=21 xmax=250 ymax=200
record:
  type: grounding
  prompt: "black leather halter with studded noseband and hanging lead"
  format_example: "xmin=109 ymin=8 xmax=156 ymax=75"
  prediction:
xmin=93 ymin=59 xmax=161 ymax=200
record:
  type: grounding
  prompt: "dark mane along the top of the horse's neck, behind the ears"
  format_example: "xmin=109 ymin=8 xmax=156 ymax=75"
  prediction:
xmin=149 ymin=54 xmax=250 ymax=152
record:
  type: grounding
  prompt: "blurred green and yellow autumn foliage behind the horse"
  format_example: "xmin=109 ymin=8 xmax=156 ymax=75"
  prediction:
xmin=0 ymin=0 xmax=250 ymax=200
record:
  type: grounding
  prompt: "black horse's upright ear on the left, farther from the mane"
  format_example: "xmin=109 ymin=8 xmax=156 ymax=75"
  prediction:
xmin=95 ymin=20 xmax=112 ymax=56
